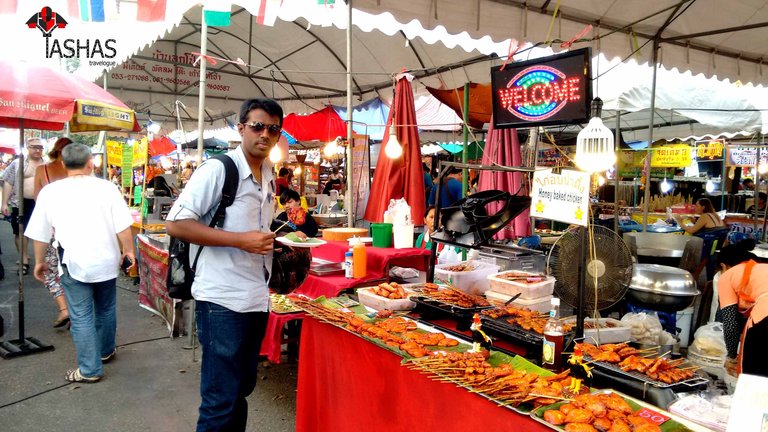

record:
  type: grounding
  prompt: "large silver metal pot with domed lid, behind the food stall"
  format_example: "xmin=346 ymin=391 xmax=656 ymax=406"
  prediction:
xmin=627 ymin=264 xmax=700 ymax=312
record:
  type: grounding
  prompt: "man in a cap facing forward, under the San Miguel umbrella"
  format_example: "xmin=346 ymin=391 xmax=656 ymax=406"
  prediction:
xmin=2 ymin=138 xmax=44 ymax=275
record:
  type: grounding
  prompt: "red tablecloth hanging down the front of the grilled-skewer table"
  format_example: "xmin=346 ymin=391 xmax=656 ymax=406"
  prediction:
xmin=296 ymin=317 xmax=550 ymax=432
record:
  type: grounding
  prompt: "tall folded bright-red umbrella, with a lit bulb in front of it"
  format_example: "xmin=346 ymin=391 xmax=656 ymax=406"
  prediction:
xmin=365 ymin=74 xmax=426 ymax=225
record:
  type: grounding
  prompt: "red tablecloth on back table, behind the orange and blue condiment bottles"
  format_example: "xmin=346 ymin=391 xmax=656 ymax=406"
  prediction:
xmin=312 ymin=241 xmax=430 ymax=277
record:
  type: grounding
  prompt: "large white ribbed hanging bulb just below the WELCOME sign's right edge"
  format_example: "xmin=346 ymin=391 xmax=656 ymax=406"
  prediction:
xmin=576 ymin=98 xmax=616 ymax=173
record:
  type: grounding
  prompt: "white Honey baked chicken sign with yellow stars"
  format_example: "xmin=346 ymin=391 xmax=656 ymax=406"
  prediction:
xmin=531 ymin=169 xmax=589 ymax=226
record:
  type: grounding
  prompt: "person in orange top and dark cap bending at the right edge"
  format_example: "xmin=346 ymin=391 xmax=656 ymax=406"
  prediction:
xmin=717 ymin=239 xmax=768 ymax=377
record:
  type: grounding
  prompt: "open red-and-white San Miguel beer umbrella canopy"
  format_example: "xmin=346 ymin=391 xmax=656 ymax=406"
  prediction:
xmin=0 ymin=60 xmax=141 ymax=132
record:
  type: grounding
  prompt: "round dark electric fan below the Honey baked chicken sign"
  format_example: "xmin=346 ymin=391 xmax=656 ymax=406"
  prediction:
xmin=547 ymin=226 xmax=632 ymax=314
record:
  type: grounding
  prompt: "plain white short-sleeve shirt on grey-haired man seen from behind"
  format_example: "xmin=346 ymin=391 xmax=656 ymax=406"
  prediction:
xmin=24 ymin=176 xmax=133 ymax=283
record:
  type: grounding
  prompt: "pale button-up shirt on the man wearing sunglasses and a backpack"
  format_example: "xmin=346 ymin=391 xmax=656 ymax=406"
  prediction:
xmin=166 ymin=147 xmax=275 ymax=312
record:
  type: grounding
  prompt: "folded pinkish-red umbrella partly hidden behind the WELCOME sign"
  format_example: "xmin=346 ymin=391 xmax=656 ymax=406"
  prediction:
xmin=477 ymin=120 xmax=531 ymax=240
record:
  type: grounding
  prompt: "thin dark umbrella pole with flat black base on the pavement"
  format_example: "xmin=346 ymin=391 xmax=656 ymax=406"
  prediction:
xmin=0 ymin=120 xmax=53 ymax=359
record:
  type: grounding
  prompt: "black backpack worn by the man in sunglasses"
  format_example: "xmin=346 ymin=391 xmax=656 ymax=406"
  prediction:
xmin=165 ymin=155 xmax=240 ymax=300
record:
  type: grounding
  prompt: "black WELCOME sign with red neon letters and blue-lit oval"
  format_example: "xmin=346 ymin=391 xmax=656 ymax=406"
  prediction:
xmin=491 ymin=48 xmax=592 ymax=128
